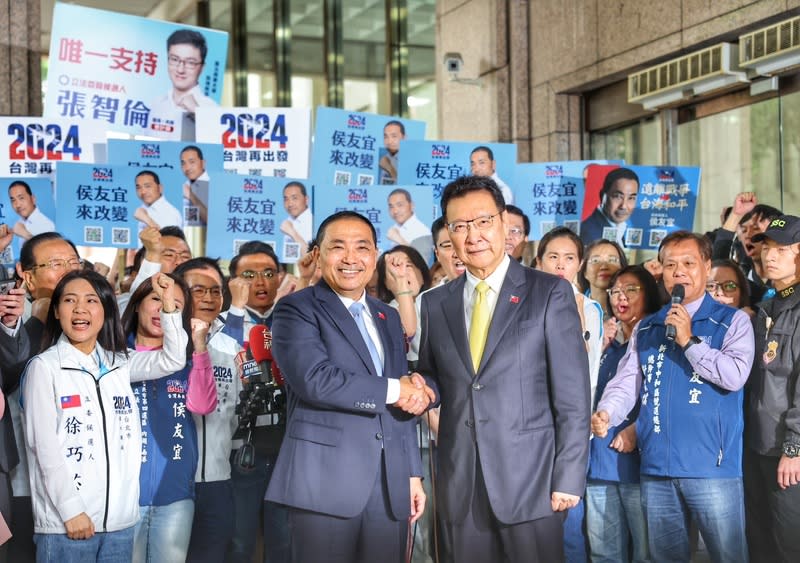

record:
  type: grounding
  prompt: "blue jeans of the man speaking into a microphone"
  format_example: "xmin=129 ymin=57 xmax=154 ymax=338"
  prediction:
xmin=641 ymin=475 xmax=748 ymax=563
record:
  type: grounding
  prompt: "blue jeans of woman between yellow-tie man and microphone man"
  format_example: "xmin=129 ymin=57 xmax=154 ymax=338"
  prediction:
xmin=586 ymin=481 xmax=650 ymax=563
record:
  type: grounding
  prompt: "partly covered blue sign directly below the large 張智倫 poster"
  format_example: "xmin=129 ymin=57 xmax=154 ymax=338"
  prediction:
xmin=108 ymin=139 xmax=223 ymax=227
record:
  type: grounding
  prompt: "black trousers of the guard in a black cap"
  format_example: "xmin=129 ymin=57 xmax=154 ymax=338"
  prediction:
xmin=743 ymin=448 xmax=800 ymax=563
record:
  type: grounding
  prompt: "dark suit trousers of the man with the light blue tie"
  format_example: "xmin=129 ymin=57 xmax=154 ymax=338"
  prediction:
xmin=289 ymin=454 xmax=408 ymax=563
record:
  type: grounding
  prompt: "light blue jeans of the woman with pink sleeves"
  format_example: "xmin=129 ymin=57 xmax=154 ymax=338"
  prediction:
xmin=133 ymin=499 xmax=194 ymax=563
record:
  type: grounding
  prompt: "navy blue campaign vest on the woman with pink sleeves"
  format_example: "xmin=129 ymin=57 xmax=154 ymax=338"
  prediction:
xmin=131 ymin=363 xmax=197 ymax=506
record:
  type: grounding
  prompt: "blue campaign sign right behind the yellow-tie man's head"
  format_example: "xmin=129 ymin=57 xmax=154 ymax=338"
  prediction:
xmin=398 ymin=141 xmax=517 ymax=213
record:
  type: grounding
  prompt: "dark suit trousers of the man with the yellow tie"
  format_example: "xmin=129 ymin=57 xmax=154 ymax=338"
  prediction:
xmin=444 ymin=456 xmax=566 ymax=563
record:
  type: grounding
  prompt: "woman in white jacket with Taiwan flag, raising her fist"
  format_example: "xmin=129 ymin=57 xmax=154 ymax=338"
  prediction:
xmin=21 ymin=270 xmax=187 ymax=560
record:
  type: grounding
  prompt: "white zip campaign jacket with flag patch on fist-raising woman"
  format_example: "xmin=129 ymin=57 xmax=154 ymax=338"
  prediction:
xmin=21 ymin=312 xmax=188 ymax=534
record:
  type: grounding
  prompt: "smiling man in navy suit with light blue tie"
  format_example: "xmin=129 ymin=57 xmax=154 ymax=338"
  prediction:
xmin=267 ymin=211 xmax=432 ymax=563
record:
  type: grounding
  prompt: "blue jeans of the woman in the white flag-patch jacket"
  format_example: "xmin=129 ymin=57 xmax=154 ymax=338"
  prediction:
xmin=33 ymin=526 xmax=133 ymax=563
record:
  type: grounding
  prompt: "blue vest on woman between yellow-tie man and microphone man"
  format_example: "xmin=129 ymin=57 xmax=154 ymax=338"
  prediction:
xmin=589 ymin=340 xmax=639 ymax=483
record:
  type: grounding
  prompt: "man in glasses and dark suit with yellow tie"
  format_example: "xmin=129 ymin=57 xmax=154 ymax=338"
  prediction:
xmin=419 ymin=176 xmax=590 ymax=563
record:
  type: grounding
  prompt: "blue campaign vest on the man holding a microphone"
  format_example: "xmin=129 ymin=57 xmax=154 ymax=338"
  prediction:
xmin=636 ymin=294 xmax=744 ymax=478
